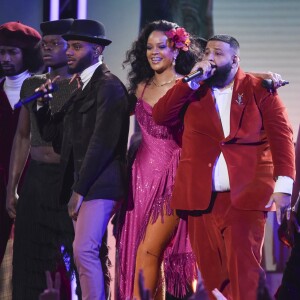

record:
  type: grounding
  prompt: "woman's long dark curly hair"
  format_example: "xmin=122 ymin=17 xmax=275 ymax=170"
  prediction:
xmin=123 ymin=20 xmax=203 ymax=94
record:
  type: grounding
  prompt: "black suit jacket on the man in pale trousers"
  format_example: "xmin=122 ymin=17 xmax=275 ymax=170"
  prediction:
xmin=38 ymin=64 xmax=129 ymax=201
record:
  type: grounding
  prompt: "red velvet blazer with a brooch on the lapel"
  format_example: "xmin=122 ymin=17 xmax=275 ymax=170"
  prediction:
xmin=153 ymin=69 xmax=295 ymax=210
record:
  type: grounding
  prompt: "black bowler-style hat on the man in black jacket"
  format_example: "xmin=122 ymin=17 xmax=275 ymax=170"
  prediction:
xmin=62 ymin=19 xmax=111 ymax=46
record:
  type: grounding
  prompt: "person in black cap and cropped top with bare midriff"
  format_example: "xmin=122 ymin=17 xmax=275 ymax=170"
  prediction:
xmin=7 ymin=19 xmax=77 ymax=299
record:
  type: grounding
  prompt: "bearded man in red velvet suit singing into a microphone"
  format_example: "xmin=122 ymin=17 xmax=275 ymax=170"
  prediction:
xmin=153 ymin=35 xmax=295 ymax=300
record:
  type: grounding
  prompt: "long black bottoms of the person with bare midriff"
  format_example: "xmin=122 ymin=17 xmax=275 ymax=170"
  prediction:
xmin=13 ymin=160 xmax=74 ymax=300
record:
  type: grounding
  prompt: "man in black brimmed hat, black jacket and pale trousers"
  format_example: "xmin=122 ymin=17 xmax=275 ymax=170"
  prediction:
xmin=36 ymin=20 xmax=129 ymax=300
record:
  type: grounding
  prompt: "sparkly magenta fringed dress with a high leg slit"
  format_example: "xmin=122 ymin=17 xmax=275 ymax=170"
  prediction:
xmin=116 ymin=92 xmax=197 ymax=300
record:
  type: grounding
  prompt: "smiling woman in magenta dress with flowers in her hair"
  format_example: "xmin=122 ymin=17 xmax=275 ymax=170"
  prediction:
xmin=117 ymin=20 xmax=202 ymax=300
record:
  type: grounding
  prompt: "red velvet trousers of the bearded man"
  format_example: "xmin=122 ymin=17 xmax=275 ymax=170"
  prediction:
xmin=188 ymin=192 xmax=266 ymax=300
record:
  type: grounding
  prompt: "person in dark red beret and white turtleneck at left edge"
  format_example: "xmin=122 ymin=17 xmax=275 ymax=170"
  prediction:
xmin=0 ymin=22 xmax=43 ymax=299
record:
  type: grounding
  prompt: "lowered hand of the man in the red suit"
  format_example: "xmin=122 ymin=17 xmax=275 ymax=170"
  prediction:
xmin=265 ymin=193 xmax=291 ymax=225
